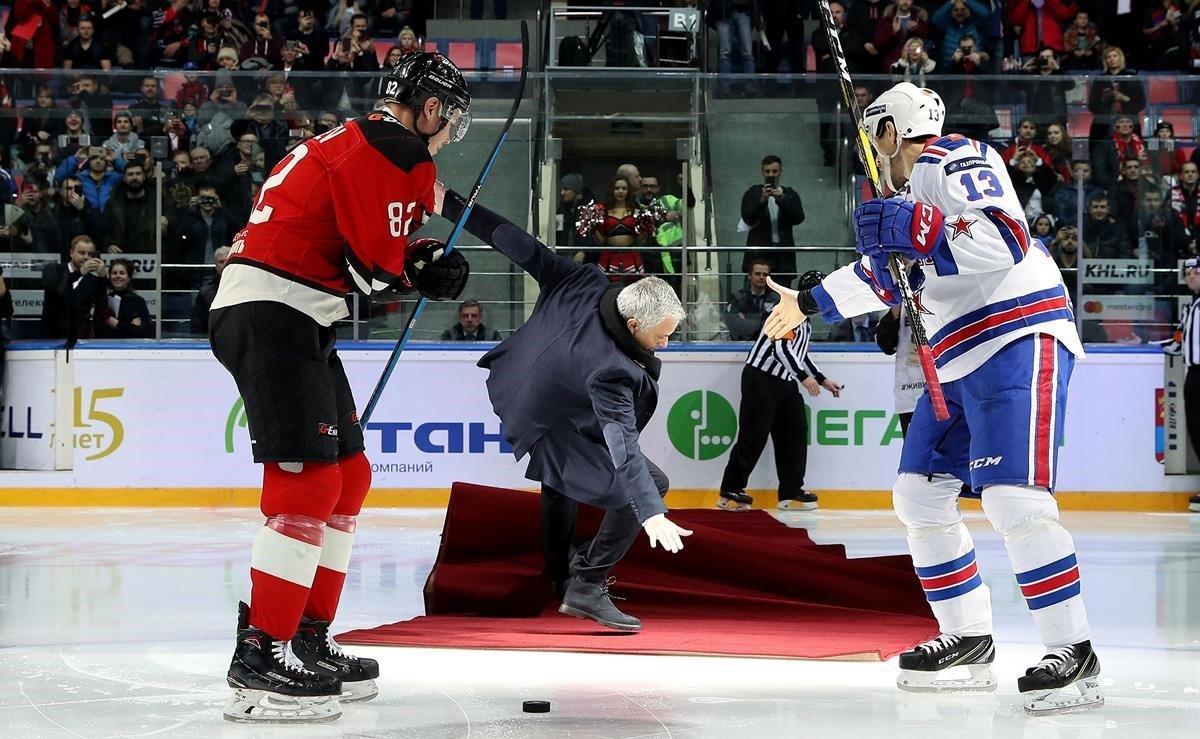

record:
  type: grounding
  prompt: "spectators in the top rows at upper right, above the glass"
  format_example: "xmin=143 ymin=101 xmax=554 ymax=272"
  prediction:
xmin=706 ymin=0 xmax=1200 ymax=76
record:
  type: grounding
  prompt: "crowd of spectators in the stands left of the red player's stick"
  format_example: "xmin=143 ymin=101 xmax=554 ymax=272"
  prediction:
xmin=0 ymin=0 xmax=451 ymax=338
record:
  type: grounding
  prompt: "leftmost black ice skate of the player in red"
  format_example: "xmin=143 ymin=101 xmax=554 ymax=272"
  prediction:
xmin=224 ymin=603 xmax=342 ymax=723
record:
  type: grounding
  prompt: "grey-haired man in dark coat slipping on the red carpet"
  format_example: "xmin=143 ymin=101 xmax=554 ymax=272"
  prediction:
xmin=434 ymin=184 xmax=691 ymax=631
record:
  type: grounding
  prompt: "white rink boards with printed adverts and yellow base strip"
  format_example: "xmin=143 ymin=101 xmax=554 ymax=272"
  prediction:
xmin=0 ymin=343 xmax=1196 ymax=510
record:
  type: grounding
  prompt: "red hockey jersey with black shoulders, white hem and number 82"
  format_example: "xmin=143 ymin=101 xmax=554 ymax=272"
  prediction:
xmin=212 ymin=112 xmax=437 ymax=326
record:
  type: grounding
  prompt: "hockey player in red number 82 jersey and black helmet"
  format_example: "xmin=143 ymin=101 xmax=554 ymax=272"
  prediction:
xmin=210 ymin=53 xmax=470 ymax=722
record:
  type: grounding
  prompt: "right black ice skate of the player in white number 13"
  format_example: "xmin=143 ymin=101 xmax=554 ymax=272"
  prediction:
xmin=1016 ymin=641 xmax=1104 ymax=716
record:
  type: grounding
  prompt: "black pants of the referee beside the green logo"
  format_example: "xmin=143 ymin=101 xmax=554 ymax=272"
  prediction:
xmin=721 ymin=365 xmax=809 ymax=500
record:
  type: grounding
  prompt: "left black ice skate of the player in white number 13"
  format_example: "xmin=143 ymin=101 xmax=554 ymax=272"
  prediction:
xmin=896 ymin=633 xmax=996 ymax=692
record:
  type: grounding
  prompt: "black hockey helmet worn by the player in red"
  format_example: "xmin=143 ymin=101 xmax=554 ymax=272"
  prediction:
xmin=383 ymin=52 xmax=470 ymax=142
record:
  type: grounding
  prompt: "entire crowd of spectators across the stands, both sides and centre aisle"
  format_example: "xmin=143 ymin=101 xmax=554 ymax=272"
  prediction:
xmin=0 ymin=0 xmax=1200 ymax=337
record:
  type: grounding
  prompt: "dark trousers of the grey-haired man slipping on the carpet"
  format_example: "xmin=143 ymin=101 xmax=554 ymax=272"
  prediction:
xmin=541 ymin=459 xmax=670 ymax=583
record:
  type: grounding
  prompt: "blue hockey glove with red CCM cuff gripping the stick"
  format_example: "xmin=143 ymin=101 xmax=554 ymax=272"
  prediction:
xmin=854 ymin=198 xmax=946 ymax=259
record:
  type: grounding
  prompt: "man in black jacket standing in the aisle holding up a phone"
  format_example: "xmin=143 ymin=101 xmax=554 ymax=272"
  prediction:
xmin=742 ymin=154 xmax=804 ymax=284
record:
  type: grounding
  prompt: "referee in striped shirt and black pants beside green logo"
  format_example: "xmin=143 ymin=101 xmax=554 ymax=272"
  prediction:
xmin=719 ymin=270 xmax=841 ymax=511
